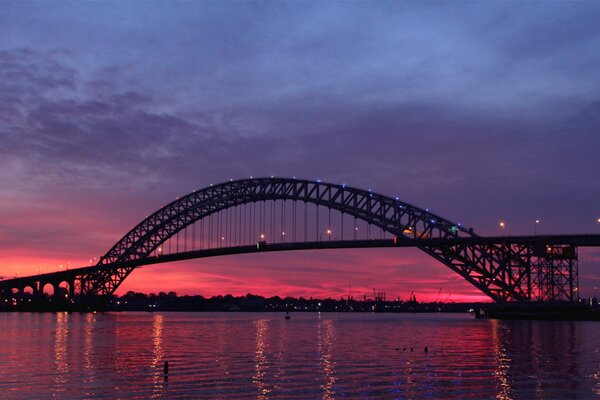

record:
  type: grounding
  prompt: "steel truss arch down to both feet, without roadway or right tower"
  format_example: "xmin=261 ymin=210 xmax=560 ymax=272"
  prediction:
xmin=86 ymin=178 xmax=530 ymax=300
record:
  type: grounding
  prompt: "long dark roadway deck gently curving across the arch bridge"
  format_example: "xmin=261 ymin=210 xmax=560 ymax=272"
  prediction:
xmin=0 ymin=234 xmax=600 ymax=290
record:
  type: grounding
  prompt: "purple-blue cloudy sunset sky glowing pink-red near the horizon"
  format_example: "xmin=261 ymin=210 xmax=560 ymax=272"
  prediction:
xmin=0 ymin=1 xmax=600 ymax=301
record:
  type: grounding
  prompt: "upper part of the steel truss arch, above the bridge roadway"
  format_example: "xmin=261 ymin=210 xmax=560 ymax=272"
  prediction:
xmin=98 ymin=178 xmax=475 ymax=265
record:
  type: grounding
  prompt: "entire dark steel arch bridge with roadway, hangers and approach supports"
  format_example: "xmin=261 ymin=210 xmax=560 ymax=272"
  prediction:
xmin=0 ymin=177 xmax=600 ymax=307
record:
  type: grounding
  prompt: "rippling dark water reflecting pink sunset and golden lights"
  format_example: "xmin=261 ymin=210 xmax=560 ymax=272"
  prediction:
xmin=0 ymin=312 xmax=600 ymax=400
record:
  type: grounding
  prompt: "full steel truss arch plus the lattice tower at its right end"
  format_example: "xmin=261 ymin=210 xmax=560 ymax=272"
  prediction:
xmin=0 ymin=178 xmax=577 ymax=301
